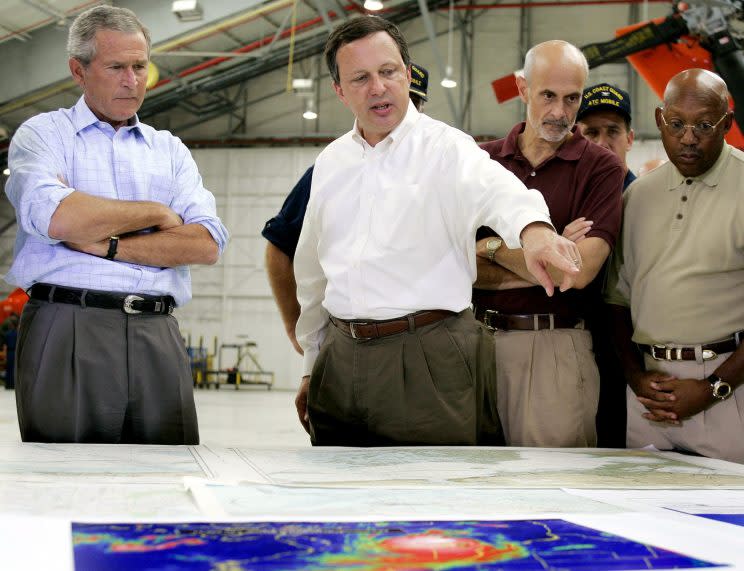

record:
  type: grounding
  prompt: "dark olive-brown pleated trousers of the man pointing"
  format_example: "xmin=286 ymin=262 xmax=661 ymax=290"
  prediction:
xmin=308 ymin=309 xmax=503 ymax=446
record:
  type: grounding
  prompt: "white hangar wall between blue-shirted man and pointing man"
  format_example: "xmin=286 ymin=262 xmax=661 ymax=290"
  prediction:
xmin=177 ymin=147 xmax=320 ymax=394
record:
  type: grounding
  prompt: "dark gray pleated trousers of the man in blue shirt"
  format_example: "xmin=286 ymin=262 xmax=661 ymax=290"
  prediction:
xmin=16 ymin=299 xmax=199 ymax=444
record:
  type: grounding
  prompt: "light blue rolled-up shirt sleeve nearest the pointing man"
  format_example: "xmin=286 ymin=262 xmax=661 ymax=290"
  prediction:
xmin=170 ymin=137 xmax=229 ymax=254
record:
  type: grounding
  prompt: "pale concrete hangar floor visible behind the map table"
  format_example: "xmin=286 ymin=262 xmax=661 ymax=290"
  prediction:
xmin=0 ymin=385 xmax=310 ymax=447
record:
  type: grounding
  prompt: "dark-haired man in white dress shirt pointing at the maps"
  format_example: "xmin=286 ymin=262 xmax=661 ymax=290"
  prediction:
xmin=295 ymin=16 xmax=581 ymax=446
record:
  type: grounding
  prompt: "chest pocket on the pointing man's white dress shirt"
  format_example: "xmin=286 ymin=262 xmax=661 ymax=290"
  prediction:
xmin=370 ymin=184 xmax=429 ymax=251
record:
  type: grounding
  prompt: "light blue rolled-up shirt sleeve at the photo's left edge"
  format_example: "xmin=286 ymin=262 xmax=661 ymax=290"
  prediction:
xmin=5 ymin=122 xmax=74 ymax=244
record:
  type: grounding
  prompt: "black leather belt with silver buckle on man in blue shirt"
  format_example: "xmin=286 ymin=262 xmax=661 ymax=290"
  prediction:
xmin=29 ymin=284 xmax=176 ymax=315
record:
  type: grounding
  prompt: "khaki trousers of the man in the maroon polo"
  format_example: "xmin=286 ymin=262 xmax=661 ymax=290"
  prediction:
xmin=493 ymin=329 xmax=599 ymax=447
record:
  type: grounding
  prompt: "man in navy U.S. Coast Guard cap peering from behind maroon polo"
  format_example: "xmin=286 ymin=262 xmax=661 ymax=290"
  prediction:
xmin=576 ymin=83 xmax=636 ymax=188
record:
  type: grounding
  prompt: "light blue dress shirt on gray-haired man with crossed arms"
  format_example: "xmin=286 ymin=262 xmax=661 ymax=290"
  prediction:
xmin=5 ymin=97 xmax=228 ymax=306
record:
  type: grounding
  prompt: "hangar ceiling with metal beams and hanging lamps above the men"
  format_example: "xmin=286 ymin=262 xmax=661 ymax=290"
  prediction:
xmin=0 ymin=0 xmax=671 ymax=172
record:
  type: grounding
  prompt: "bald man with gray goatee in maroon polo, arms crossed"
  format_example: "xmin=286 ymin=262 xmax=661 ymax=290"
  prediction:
xmin=473 ymin=41 xmax=625 ymax=452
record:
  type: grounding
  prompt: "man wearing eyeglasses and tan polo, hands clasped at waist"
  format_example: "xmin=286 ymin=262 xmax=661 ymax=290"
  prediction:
xmin=605 ymin=69 xmax=744 ymax=462
